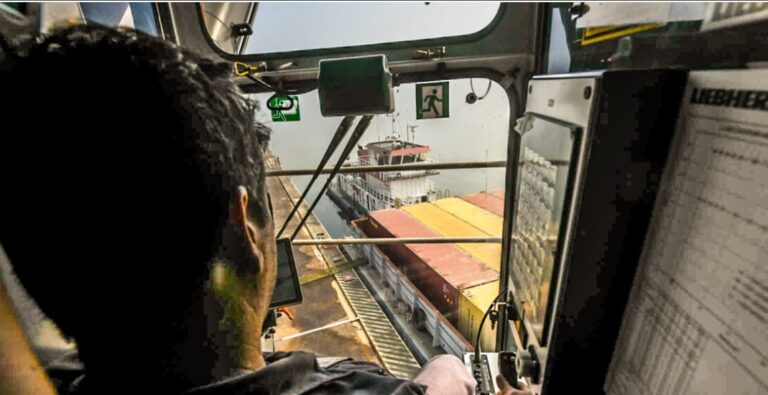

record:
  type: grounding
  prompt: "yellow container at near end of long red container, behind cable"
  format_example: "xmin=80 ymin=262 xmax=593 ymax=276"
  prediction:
xmin=457 ymin=280 xmax=499 ymax=351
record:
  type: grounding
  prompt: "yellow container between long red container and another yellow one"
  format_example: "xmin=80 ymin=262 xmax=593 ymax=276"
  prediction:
xmin=402 ymin=203 xmax=501 ymax=273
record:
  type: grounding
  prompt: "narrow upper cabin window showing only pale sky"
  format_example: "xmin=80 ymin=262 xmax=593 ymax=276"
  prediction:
xmin=202 ymin=2 xmax=499 ymax=54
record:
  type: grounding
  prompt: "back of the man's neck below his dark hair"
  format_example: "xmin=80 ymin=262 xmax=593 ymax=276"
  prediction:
xmin=86 ymin=264 xmax=266 ymax=392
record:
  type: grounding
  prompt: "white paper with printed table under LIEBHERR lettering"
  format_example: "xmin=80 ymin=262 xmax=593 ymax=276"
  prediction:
xmin=605 ymin=70 xmax=768 ymax=395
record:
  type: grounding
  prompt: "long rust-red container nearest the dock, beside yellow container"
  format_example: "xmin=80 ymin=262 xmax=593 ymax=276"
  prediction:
xmin=356 ymin=209 xmax=499 ymax=326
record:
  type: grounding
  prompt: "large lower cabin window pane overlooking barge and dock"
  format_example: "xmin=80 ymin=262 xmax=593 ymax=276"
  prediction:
xmin=251 ymin=78 xmax=511 ymax=366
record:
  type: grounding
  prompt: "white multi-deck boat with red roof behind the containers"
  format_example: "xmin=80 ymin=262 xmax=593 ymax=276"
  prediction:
xmin=327 ymin=135 xmax=438 ymax=218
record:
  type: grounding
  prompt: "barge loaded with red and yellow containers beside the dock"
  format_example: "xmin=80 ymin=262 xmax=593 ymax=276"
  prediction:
xmin=351 ymin=190 xmax=504 ymax=354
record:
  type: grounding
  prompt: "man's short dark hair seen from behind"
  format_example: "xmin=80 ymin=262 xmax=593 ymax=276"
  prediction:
xmin=0 ymin=26 xmax=269 ymax=372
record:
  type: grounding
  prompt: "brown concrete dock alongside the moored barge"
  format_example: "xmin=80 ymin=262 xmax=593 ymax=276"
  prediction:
xmin=266 ymin=155 xmax=420 ymax=378
